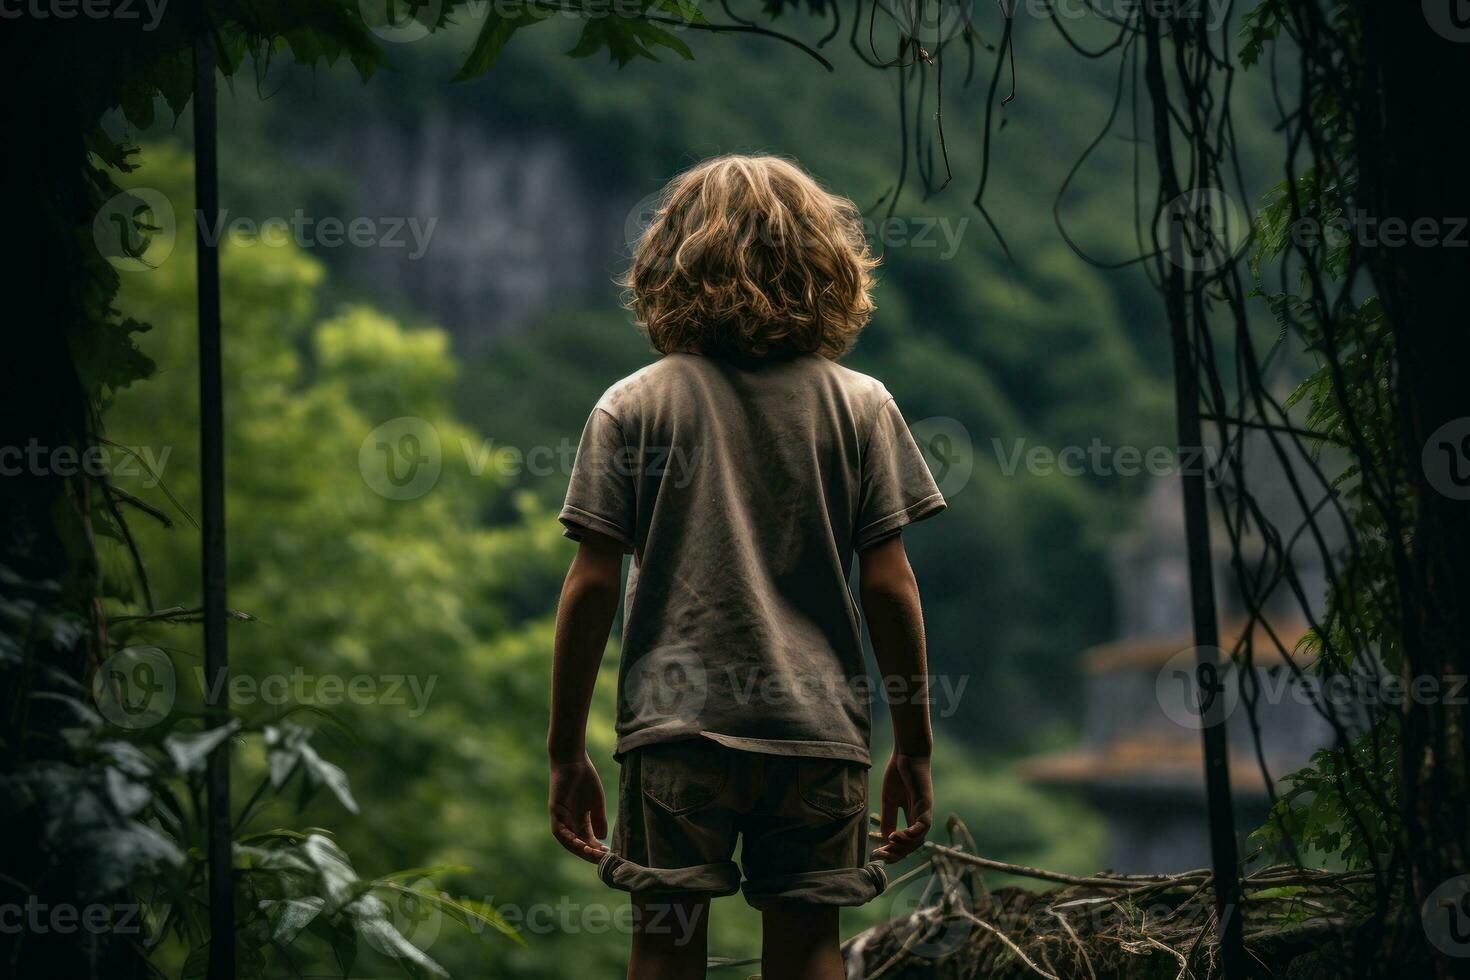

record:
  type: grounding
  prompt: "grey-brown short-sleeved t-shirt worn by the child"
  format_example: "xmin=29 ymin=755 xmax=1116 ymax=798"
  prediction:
xmin=560 ymin=354 xmax=944 ymax=763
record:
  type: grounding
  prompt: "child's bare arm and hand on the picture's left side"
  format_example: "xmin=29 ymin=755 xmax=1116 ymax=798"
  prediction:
xmin=547 ymin=530 xmax=623 ymax=862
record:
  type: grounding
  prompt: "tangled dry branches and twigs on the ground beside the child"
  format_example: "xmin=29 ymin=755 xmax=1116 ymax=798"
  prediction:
xmin=844 ymin=817 xmax=1373 ymax=980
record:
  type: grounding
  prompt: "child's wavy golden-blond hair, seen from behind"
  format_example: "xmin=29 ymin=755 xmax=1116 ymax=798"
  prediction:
xmin=620 ymin=154 xmax=878 ymax=360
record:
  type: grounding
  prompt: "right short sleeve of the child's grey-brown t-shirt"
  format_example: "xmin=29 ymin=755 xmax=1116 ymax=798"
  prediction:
xmin=853 ymin=398 xmax=945 ymax=551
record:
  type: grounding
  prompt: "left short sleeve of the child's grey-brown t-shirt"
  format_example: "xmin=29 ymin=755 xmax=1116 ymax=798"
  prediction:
xmin=559 ymin=407 xmax=637 ymax=551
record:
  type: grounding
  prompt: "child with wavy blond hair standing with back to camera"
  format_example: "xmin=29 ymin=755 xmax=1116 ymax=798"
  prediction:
xmin=547 ymin=156 xmax=944 ymax=980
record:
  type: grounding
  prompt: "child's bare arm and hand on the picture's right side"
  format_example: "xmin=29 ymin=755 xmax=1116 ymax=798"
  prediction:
xmin=858 ymin=535 xmax=933 ymax=862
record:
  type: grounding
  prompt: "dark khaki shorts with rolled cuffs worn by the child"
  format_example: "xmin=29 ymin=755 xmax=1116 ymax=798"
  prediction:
xmin=597 ymin=738 xmax=888 ymax=908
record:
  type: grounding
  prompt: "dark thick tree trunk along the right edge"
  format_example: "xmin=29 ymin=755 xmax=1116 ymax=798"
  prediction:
xmin=1358 ymin=0 xmax=1470 ymax=977
